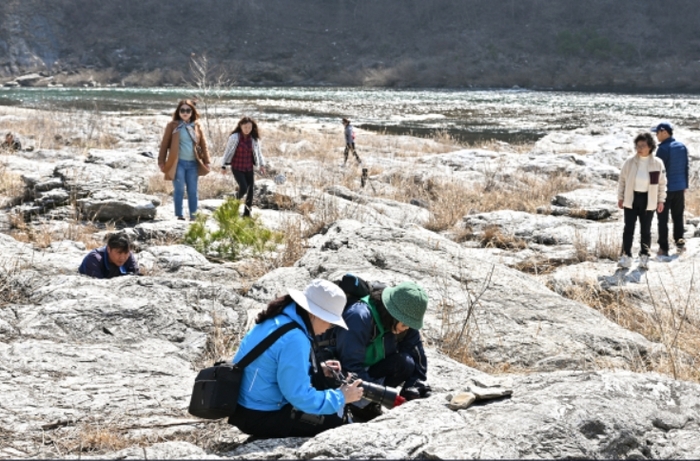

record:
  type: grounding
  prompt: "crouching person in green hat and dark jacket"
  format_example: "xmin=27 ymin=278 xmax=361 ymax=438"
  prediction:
xmin=333 ymin=274 xmax=430 ymax=420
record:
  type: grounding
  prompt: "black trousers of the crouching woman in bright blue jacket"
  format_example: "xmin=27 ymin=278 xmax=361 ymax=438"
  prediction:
xmin=228 ymin=404 xmax=347 ymax=439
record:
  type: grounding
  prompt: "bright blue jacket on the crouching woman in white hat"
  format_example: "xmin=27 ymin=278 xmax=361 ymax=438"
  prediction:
xmin=233 ymin=303 xmax=345 ymax=415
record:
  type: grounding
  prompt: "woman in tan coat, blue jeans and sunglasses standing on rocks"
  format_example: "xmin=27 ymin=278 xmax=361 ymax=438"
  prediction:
xmin=158 ymin=99 xmax=211 ymax=220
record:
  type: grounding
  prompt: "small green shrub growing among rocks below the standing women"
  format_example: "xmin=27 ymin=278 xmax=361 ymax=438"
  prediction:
xmin=185 ymin=198 xmax=282 ymax=260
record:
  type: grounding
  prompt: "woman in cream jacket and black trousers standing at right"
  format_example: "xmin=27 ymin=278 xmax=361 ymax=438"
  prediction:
xmin=617 ymin=133 xmax=666 ymax=269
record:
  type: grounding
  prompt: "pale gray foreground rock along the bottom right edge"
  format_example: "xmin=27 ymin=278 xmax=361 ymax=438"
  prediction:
xmin=213 ymin=364 xmax=700 ymax=459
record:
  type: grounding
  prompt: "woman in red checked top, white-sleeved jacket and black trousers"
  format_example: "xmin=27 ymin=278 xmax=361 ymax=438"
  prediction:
xmin=221 ymin=117 xmax=265 ymax=217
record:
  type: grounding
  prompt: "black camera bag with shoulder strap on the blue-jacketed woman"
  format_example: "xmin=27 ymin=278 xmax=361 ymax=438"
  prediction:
xmin=188 ymin=322 xmax=301 ymax=419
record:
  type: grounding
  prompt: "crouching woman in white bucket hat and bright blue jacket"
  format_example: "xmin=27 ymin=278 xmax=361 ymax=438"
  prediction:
xmin=229 ymin=279 xmax=362 ymax=438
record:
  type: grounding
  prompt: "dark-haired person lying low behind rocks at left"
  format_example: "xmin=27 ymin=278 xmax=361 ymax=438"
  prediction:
xmin=78 ymin=233 xmax=139 ymax=279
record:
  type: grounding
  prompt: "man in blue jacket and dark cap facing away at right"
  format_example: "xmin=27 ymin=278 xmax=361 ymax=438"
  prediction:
xmin=651 ymin=122 xmax=689 ymax=256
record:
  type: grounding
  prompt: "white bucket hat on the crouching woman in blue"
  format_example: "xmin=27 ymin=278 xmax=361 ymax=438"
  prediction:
xmin=288 ymin=279 xmax=348 ymax=330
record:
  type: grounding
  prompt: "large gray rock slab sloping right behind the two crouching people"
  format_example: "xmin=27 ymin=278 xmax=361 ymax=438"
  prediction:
xmin=255 ymin=220 xmax=657 ymax=371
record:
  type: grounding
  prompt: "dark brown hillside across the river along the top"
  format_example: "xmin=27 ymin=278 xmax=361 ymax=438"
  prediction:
xmin=0 ymin=0 xmax=700 ymax=91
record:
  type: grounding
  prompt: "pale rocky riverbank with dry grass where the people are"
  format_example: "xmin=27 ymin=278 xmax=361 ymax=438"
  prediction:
xmin=0 ymin=109 xmax=700 ymax=459
